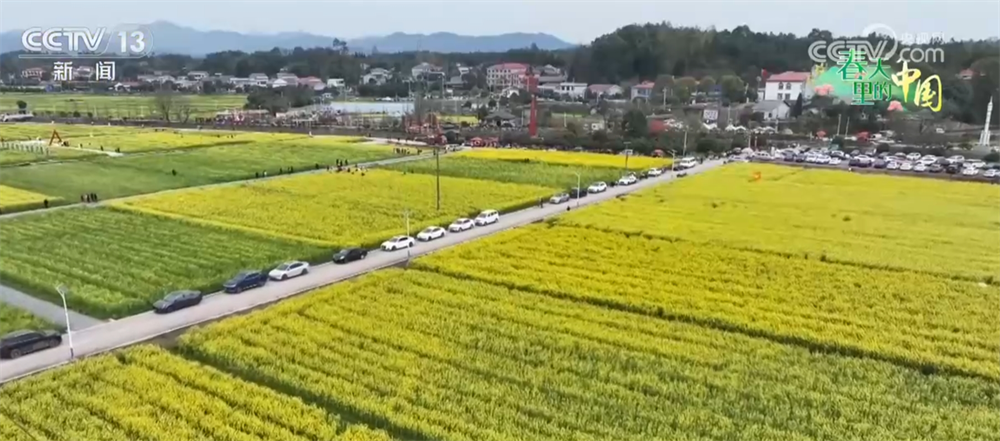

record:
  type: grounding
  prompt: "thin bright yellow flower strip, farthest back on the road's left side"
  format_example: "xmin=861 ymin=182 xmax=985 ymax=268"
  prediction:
xmin=458 ymin=148 xmax=670 ymax=170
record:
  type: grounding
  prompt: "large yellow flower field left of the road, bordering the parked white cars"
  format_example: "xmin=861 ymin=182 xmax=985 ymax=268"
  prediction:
xmin=115 ymin=170 xmax=553 ymax=246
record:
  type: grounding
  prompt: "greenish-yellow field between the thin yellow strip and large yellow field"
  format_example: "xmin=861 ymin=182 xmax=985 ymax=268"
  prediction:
xmin=386 ymin=155 xmax=622 ymax=190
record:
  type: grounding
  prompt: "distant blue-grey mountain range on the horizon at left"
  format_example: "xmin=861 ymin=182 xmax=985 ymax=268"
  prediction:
xmin=0 ymin=21 xmax=575 ymax=56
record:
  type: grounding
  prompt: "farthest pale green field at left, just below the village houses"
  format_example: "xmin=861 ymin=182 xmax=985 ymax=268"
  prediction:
xmin=0 ymin=92 xmax=246 ymax=118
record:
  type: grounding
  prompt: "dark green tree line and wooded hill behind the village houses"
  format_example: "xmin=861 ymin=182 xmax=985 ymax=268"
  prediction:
xmin=0 ymin=22 xmax=1000 ymax=123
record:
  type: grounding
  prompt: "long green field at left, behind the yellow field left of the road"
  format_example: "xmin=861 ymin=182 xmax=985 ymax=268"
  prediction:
xmin=2 ymin=139 xmax=395 ymax=202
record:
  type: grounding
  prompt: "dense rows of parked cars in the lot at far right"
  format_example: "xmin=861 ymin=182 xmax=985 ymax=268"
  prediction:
xmin=744 ymin=148 xmax=1000 ymax=179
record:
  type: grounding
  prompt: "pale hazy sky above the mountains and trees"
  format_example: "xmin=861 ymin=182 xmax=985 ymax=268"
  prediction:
xmin=0 ymin=0 xmax=1000 ymax=43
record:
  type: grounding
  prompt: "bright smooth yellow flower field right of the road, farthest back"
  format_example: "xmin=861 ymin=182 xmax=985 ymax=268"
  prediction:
xmin=560 ymin=164 xmax=1000 ymax=283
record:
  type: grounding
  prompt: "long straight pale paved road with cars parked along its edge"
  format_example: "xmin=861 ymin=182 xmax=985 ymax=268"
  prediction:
xmin=0 ymin=161 xmax=721 ymax=383
